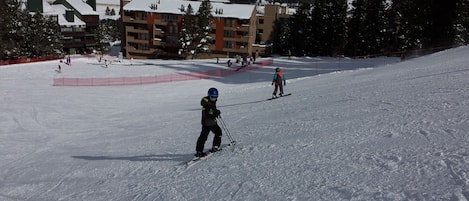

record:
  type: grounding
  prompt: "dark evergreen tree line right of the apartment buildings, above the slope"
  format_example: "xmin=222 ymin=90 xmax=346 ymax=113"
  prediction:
xmin=272 ymin=0 xmax=469 ymax=56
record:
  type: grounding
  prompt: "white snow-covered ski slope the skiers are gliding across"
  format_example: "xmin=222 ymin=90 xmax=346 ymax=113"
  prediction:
xmin=0 ymin=47 xmax=469 ymax=201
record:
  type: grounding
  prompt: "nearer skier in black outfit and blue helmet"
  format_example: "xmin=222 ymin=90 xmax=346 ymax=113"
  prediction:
xmin=195 ymin=88 xmax=222 ymax=157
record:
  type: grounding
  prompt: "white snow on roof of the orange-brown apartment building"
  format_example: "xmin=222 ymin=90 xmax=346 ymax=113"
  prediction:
xmin=124 ymin=0 xmax=256 ymax=19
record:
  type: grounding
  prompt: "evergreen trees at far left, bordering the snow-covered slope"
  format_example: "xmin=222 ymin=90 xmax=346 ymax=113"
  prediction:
xmin=0 ymin=0 xmax=63 ymax=60
